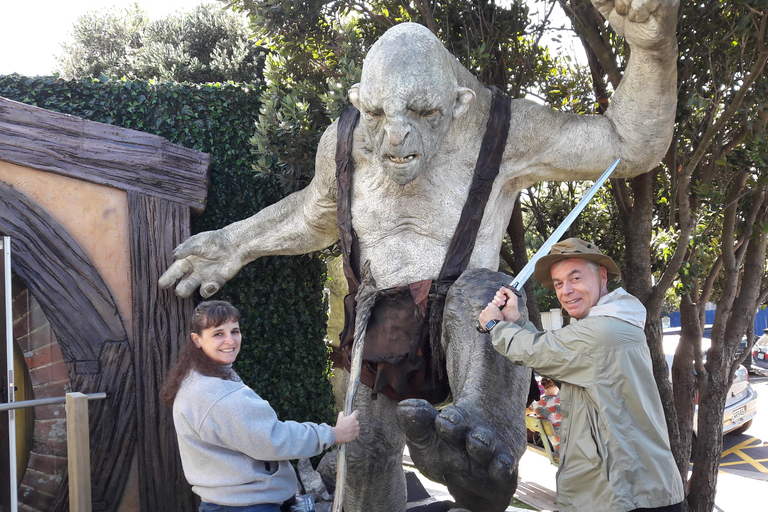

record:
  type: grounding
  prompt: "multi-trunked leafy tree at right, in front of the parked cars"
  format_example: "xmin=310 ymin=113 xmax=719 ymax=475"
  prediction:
xmin=559 ymin=0 xmax=768 ymax=511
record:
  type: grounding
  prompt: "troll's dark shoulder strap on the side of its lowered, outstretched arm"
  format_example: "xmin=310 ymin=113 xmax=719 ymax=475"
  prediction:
xmin=336 ymin=105 xmax=360 ymax=294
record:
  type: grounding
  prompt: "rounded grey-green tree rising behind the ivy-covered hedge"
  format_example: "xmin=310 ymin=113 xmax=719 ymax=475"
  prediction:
xmin=58 ymin=4 xmax=264 ymax=83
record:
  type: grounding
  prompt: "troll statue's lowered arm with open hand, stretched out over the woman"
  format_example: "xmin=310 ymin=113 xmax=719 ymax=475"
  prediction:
xmin=158 ymin=125 xmax=339 ymax=297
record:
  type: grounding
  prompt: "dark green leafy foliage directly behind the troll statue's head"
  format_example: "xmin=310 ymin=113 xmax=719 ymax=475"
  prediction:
xmin=227 ymin=0 xmax=553 ymax=191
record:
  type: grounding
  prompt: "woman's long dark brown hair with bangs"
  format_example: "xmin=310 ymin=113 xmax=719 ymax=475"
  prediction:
xmin=160 ymin=300 xmax=240 ymax=406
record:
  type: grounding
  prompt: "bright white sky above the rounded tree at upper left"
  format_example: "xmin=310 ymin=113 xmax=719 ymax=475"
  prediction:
xmin=0 ymin=0 xmax=203 ymax=76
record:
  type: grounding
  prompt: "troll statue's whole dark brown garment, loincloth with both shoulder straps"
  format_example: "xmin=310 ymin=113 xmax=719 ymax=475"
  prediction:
xmin=336 ymin=88 xmax=510 ymax=403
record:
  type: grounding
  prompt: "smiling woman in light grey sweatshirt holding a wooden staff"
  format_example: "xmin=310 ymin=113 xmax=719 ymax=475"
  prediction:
xmin=161 ymin=301 xmax=360 ymax=512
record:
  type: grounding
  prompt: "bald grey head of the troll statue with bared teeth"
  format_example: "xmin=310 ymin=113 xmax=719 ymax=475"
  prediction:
xmin=349 ymin=23 xmax=475 ymax=185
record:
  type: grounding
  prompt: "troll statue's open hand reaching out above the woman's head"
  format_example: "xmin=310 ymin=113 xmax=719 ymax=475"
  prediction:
xmin=157 ymin=230 xmax=245 ymax=297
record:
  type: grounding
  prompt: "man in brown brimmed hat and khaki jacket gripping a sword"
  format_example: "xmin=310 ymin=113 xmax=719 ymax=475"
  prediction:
xmin=479 ymin=238 xmax=685 ymax=512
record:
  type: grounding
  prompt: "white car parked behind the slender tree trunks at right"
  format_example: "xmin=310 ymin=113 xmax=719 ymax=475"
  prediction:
xmin=663 ymin=327 xmax=757 ymax=434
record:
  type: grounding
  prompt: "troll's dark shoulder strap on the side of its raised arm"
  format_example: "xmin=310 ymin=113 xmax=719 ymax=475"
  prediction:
xmin=438 ymin=87 xmax=512 ymax=282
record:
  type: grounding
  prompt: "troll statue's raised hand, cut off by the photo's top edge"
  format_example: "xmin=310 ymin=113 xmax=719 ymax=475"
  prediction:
xmin=592 ymin=0 xmax=680 ymax=50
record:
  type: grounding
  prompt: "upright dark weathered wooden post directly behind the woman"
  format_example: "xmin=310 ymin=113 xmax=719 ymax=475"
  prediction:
xmin=128 ymin=193 xmax=196 ymax=512
